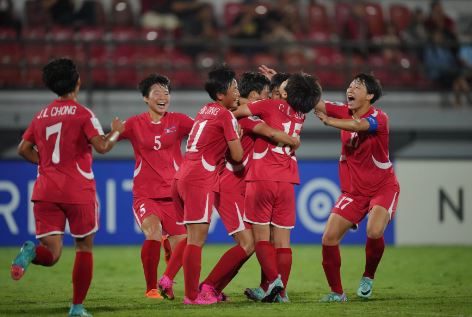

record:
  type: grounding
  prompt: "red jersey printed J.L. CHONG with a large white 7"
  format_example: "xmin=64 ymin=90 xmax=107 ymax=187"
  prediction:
xmin=23 ymin=99 xmax=103 ymax=204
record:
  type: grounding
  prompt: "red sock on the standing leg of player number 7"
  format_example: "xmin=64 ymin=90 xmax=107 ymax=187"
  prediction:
xmin=72 ymin=251 xmax=93 ymax=305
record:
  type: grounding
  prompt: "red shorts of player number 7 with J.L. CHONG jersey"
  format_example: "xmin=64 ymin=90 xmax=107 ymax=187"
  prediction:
xmin=33 ymin=201 xmax=99 ymax=239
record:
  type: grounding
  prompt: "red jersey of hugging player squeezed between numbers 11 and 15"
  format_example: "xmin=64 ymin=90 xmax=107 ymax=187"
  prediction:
xmin=220 ymin=117 xmax=264 ymax=195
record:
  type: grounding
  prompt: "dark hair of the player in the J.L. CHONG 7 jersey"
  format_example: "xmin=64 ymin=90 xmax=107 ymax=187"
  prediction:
xmin=43 ymin=58 xmax=79 ymax=96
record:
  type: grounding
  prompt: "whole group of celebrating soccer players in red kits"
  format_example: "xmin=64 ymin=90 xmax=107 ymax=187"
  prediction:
xmin=11 ymin=58 xmax=400 ymax=316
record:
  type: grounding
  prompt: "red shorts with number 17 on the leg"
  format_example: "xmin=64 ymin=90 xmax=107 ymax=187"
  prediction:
xmin=331 ymin=185 xmax=400 ymax=224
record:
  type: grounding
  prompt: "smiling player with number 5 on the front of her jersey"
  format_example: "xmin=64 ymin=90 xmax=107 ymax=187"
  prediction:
xmin=116 ymin=74 xmax=193 ymax=299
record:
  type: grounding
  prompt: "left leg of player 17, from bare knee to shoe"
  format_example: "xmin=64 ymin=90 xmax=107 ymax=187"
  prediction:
xmin=320 ymin=213 xmax=353 ymax=302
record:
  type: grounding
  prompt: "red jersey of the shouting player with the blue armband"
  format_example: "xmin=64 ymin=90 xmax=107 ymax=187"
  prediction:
xmin=325 ymin=102 xmax=398 ymax=196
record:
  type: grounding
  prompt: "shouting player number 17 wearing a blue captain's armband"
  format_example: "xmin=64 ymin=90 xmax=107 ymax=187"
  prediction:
xmin=315 ymin=74 xmax=400 ymax=302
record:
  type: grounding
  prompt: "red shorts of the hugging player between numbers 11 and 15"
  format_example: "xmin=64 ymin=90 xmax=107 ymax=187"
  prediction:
xmin=215 ymin=192 xmax=251 ymax=236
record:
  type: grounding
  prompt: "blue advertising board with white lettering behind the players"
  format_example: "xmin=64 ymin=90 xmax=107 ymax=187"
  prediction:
xmin=0 ymin=160 xmax=395 ymax=246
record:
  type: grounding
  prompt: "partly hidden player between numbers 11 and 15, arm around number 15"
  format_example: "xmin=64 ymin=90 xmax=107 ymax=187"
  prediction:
xmin=197 ymin=72 xmax=300 ymax=301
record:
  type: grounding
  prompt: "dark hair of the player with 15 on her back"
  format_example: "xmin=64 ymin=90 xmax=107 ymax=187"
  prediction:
xmin=285 ymin=73 xmax=321 ymax=113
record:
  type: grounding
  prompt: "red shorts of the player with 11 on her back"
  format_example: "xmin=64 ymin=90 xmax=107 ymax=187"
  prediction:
xmin=172 ymin=179 xmax=215 ymax=224
